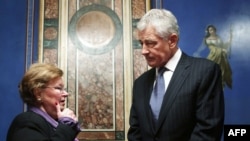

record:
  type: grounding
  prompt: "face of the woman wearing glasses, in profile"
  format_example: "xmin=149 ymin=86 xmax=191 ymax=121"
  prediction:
xmin=35 ymin=77 xmax=69 ymax=119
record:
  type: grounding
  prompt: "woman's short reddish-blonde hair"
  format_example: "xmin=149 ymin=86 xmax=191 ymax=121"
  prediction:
xmin=18 ymin=63 xmax=63 ymax=106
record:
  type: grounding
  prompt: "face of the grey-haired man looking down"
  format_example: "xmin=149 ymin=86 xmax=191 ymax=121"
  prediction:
xmin=138 ymin=26 xmax=177 ymax=67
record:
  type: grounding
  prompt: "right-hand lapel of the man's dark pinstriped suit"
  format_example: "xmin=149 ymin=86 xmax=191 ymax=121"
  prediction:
xmin=156 ymin=53 xmax=190 ymax=132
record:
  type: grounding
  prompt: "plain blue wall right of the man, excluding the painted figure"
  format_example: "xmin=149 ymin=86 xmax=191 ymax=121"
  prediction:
xmin=162 ymin=0 xmax=250 ymax=124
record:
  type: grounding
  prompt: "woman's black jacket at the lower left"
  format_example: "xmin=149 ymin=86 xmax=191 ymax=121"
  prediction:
xmin=7 ymin=111 xmax=78 ymax=141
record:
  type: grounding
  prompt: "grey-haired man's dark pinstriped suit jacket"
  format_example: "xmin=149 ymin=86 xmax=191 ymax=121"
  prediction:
xmin=128 ymin=53 xmax=224 ymax=141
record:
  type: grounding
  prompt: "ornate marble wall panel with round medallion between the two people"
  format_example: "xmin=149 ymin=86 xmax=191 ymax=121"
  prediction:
xmin=39 ymin=0 xmax=149 ymax=140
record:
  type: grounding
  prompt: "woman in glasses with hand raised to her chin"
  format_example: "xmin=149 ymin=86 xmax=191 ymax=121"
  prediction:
xmin=7 ymin=63 xmax=80 ymax=141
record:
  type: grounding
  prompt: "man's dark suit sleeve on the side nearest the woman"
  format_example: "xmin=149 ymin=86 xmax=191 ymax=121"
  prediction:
xmin=127 ymin=82 xmax=141 ymax=141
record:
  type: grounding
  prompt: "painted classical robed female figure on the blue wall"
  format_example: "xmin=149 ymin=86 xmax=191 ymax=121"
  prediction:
xmin=194 ymin=24 xmax=233 ymax=89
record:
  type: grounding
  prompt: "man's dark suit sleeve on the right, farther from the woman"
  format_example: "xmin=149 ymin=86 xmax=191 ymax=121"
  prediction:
xmin=190 ymin=64 xmax=224 ymax=141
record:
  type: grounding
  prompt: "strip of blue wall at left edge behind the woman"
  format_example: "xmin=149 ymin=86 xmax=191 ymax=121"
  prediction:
xmin=0 ymin=0 xmax=27 ymax=141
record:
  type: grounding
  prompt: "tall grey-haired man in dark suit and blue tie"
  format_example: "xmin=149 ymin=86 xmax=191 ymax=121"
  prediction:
xmin=128 ymin=9 xmax=224 ymax=141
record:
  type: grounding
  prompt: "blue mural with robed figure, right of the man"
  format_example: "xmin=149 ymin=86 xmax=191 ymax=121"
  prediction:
xmin=161 ymin=0 xmax=250 ymax=124
